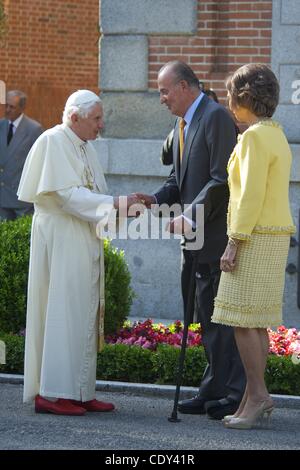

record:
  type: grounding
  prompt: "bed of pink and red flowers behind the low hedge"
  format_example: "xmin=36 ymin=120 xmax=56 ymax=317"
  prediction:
xmin=106 ymin=319 xmax=300 ymax=356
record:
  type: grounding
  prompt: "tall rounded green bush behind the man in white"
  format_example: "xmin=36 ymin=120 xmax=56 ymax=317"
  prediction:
xmin=0 ymin=217 xmax=133 ymax=334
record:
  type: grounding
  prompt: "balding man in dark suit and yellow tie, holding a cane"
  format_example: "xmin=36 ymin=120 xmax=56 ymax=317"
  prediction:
xmin=138 ymin=61 xmax=245 ymax=419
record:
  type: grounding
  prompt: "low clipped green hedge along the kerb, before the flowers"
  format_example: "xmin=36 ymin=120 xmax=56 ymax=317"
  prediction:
xmin=0 ymin=333 xmax=300 ymax=395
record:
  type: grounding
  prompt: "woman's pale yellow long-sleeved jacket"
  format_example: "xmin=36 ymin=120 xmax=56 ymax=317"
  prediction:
xmin=228 ymin=120 xmax=295 ymax=240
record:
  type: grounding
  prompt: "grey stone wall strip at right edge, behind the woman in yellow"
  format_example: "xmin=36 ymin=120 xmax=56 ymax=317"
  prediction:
xmin=272 ymin=0 xmax=300 ymax=327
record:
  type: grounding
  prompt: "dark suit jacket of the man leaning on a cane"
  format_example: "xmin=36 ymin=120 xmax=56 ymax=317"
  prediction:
xmin=155 ymin=96 xmax=236 ymax=263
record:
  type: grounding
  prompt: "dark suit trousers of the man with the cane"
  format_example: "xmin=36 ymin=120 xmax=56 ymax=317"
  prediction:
xmin=182 ymin=250 xmax=246 ymax=401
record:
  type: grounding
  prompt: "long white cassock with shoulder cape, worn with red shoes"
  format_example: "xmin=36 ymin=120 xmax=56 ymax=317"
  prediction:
xmin=18 ymin=124 xmax=113 ymax=402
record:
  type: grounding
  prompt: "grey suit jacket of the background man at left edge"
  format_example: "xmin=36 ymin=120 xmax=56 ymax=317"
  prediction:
xmin=0 ymin=115 xmax=43 ymax=209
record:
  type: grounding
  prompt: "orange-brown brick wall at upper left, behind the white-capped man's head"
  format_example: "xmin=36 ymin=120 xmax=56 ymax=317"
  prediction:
xmin=0 ymin=0 xmax=99 ymax=128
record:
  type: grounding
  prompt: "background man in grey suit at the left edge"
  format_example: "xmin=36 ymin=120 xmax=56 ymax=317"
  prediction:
xmin=0 ymin=90 xmax=43 ymax=220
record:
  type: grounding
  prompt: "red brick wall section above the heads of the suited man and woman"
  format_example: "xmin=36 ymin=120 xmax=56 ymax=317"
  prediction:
xmin=149 ymin=0 xmax=272 ymax=102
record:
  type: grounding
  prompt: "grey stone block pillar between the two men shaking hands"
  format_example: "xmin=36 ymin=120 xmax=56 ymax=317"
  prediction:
xmin=96 ymin=0 xmax=197 ymax=320
